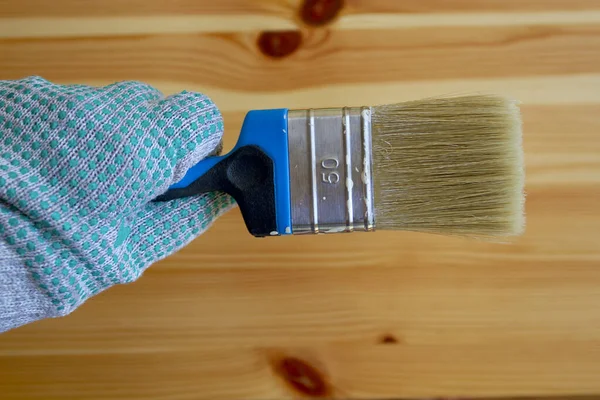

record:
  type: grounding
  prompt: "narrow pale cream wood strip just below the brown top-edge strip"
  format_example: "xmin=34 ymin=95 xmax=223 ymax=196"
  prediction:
xmin=5 ymin=10 xmax=600 ymax=38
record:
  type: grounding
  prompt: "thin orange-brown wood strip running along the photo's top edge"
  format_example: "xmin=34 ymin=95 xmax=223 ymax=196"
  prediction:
xmin=0 ymin=0 xmax=600 ymax=17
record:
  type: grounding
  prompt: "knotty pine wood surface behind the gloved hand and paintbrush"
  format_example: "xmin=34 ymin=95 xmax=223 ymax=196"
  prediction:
xmin=0 ymin=0 xmax=600 ymax=400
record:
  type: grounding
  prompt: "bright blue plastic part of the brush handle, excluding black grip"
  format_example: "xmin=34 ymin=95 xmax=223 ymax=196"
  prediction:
xmin=159 ymin=109 xmax=292 ymax=235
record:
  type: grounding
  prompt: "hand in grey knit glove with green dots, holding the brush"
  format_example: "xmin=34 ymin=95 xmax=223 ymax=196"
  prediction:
xmin=0 ymin=77 xmax=233 ymax=332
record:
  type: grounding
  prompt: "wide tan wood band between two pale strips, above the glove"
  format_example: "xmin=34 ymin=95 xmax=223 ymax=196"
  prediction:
xmin=0 ymin=25 xmax=600 ymax=93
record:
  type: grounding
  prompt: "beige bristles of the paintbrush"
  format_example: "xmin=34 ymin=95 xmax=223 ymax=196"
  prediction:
xmin=372 ymin=95 xmax=525 ymax=238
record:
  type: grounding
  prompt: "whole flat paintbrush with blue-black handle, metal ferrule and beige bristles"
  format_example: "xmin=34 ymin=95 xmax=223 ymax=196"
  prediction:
xmin=157 ymin=95 xmax=524 ymax=239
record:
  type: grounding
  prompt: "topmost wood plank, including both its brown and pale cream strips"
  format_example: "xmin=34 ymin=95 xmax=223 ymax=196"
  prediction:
xmin=5 ymin=0 xmax=600 ymax=38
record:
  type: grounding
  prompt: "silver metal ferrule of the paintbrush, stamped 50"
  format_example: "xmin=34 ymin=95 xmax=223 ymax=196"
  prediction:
xmin=288 ymin=107 xmax=375 ymax=234
